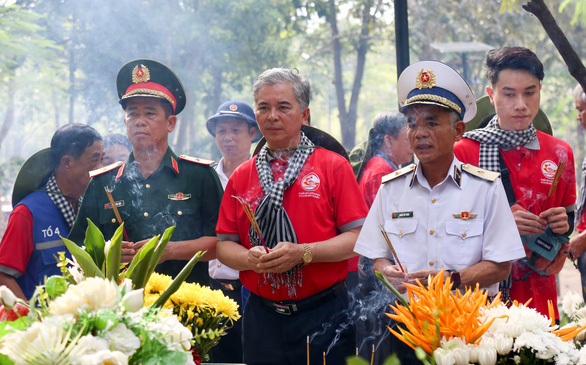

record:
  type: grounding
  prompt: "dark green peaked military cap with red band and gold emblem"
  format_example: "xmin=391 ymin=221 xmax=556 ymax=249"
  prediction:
xmin=116 ymin=59 xmax=185 ymax=115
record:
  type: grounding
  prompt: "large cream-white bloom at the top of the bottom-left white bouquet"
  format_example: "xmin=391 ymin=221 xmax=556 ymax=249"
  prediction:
xmin=49 ymin=277 xmax=120 ymax=315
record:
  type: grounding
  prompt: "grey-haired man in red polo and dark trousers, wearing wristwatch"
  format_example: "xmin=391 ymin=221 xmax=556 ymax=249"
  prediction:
xmin=216 ymin=68 xmax=367 ymax=365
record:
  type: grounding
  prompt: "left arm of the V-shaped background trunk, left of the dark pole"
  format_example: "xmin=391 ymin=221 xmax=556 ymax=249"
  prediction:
xmin=328 ymin=0 xmax=354 ymax=148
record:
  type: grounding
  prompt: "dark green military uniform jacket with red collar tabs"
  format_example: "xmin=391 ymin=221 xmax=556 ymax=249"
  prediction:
xmin=69 ymin=148 xmax=223 ymax=285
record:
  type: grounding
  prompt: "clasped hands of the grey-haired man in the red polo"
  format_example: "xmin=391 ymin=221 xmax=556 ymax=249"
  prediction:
xmin=255 ymin=242 xmax=304 ymax=273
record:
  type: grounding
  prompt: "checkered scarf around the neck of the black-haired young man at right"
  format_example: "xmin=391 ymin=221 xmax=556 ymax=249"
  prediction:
xmin=464 ymin=115 xmax=536 ymax=172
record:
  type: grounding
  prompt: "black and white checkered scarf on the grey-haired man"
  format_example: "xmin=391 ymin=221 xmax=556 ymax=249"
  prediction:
xmin=248 ymin=132 xmax=314 ymax=297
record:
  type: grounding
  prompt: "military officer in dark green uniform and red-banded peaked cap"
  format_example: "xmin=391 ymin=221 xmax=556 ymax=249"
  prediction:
xmin=69 ymin=59 xmax=222 ymax=285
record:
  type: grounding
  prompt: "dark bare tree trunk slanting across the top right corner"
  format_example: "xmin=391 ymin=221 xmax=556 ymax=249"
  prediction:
xmin=523 ymin=0 xmax=586 ymax=90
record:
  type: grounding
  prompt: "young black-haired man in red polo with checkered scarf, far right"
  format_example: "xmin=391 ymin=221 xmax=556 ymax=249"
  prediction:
xmin=454 ymin=47 xmax=576 ymax=316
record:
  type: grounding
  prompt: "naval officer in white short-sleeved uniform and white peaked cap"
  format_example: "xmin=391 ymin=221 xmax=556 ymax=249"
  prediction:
xmin=354 ymin=61 xmax=524 ymax=362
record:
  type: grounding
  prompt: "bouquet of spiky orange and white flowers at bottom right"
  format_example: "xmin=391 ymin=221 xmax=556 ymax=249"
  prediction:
xmin=377 ymin=270 xmax=585 ymax=365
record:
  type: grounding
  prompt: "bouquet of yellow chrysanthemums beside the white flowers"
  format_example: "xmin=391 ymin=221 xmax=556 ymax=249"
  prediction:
xmin=144 ymin=273 xmax=240 ymax=362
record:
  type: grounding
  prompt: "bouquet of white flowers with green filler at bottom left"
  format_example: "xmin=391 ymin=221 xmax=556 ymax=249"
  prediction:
xmin=0 ymin=276 xmax=194 ymax=365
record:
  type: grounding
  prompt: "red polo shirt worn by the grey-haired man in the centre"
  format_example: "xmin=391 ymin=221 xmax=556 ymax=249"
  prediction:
xmin=216 ymin=148 xmax=368 ymax=301
